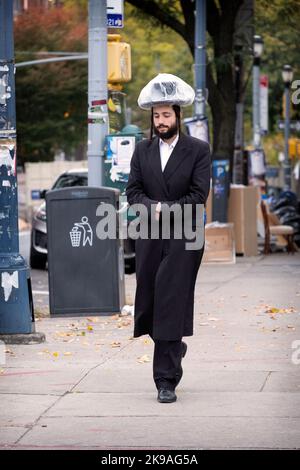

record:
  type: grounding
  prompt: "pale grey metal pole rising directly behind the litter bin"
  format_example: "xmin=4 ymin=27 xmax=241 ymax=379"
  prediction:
xmin=87 ymin=0 xmax=109 ymax=186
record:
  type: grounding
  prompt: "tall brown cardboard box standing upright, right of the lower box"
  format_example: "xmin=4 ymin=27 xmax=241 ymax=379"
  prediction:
xmin=228 ymin=185 xmax=258 ymax=256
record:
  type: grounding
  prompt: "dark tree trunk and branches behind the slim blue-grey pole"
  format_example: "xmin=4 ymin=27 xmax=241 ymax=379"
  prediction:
xmin=127 ymin=0 xmax=253 ymax=176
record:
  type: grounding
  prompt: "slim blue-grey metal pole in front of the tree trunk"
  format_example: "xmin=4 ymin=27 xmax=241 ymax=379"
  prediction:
xmin=195 ymin=0 xmax=206 ymax=119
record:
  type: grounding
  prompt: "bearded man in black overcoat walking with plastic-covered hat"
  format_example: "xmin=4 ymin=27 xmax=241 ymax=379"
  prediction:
xmin=126 ymin=74 xmax=211 ymax=403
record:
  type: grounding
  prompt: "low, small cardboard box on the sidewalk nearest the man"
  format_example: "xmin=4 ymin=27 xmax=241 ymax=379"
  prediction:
xmin=203 ymin=222 xmax=236 ymax=264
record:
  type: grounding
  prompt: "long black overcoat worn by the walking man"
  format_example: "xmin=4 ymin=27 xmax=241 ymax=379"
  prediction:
xmin=126 ymin=134 xmax=211 ymax=341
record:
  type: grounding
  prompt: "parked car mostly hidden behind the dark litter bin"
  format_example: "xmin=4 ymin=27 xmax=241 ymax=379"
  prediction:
xmin=30 ymin=168 xmax=135 ymax=274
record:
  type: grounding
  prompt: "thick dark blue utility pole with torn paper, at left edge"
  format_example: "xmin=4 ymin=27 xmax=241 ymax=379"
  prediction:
xmin=0 ymin=0 xmax=45 ymax=344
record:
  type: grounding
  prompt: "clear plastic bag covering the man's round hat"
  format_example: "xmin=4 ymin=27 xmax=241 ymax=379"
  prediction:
xmin=138 ymin=73 xmax=195 ymax=109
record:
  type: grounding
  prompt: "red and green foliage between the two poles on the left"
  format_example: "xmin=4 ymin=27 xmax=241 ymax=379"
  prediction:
xmin=15 ymin=7 xmax=87 ymax=163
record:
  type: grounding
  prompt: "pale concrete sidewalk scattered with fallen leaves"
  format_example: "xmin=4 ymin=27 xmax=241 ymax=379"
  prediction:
xmin=0 ymin=253 xmax=300 ymax=450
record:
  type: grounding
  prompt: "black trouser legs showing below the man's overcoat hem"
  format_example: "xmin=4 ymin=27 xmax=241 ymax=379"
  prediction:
xmin=152 ymin=338 xmax=182 ymax=390
